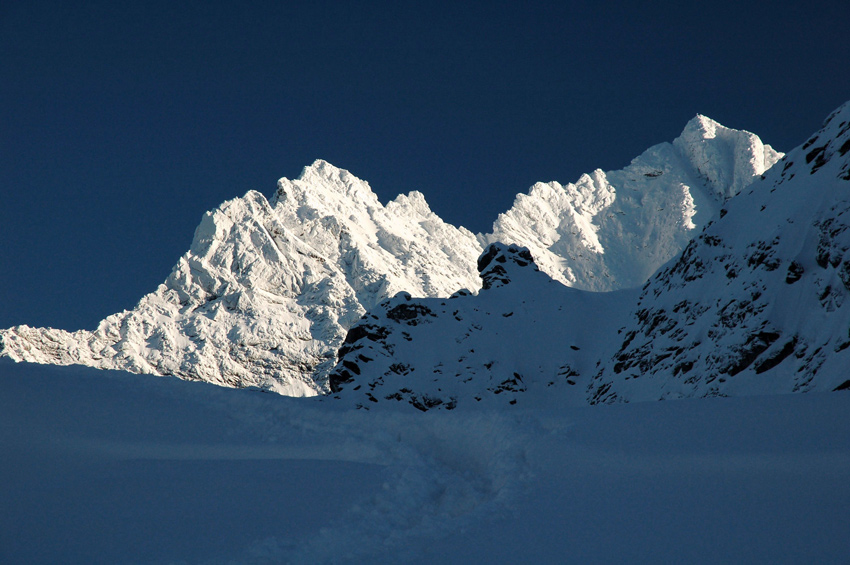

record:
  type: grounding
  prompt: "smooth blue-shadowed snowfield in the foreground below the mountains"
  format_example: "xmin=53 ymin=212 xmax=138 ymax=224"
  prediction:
xmin=0 ymin=359 xmax=850 ymax=565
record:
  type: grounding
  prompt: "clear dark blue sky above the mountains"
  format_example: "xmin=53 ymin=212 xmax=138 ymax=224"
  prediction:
xmin=0 ymin=0 xmax=850 ymax=329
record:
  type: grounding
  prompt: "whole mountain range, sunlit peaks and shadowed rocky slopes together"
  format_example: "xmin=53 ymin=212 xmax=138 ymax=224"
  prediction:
xmin=9 ymin=105 xmax=850 ymax=410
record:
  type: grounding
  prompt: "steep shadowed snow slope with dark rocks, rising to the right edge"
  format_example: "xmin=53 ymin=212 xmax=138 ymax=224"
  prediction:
xmin=587 ymin=103 xmax=850 ymax=403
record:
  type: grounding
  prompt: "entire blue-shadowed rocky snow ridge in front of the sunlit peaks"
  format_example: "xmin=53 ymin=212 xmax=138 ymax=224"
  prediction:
xmin=330 ymin=102 xmax=850 ymax=410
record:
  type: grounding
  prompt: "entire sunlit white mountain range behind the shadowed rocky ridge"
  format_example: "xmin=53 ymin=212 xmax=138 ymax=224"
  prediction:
xmin=0 ymin=116 xmax=780 ymax=396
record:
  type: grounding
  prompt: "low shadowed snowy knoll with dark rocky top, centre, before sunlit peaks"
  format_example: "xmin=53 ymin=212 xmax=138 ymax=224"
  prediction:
xmin=330 ymin=243 xmax=636 ymax=411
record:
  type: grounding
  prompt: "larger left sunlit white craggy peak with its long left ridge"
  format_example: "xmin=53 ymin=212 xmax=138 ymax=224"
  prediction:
xmin=0 ymin=161 xmax=480 ymax=396
